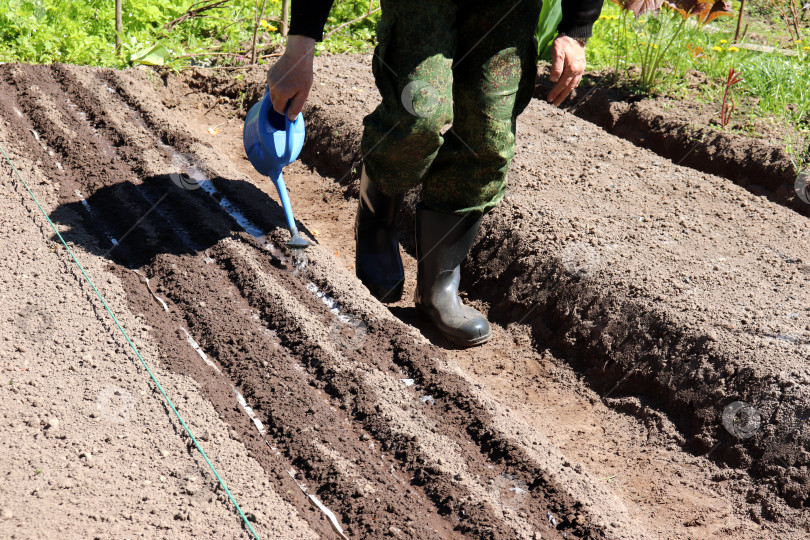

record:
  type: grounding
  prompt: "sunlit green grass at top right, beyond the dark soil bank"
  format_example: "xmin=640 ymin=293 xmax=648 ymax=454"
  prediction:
xmin=586 ymin=2 xmax=810 ymax=156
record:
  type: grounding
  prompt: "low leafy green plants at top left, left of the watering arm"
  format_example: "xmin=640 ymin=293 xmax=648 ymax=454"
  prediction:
xmin=0 ymin=0 xmax=288 ymax=68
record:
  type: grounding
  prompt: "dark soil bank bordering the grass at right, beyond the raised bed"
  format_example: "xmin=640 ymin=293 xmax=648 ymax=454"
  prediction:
xmin=535 ymin=69 xmax=810 ymax=216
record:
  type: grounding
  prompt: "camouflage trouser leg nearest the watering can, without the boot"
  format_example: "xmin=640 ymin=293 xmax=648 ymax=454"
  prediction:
xmin=361 ymin=0 xmax=458 ymax=195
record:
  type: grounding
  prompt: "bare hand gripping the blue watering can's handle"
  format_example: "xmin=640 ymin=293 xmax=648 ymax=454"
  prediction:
xmin=267 ymin=36 xmax=315 ymax=120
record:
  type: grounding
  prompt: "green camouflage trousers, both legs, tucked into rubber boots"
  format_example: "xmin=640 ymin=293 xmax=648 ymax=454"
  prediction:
xmin=361 ymin=0 xmax=540 ymax=215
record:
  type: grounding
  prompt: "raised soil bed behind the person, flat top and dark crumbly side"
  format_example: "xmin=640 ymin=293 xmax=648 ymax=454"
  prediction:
xmin=286 ymin=54 xmax=810 ymax=519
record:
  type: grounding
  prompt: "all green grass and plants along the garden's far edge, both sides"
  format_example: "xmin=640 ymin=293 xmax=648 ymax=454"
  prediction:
xmin=0 ymin=0 xmax=810 ymax=166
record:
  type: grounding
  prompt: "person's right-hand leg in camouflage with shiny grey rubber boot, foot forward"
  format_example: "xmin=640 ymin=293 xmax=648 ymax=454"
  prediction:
xmin=415 ymin=0 xmax=540 ymax=346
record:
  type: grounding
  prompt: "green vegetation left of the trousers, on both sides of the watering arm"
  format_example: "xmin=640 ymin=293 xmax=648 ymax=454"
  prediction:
xmin=0 ymin=0 xmax=379 ymax=69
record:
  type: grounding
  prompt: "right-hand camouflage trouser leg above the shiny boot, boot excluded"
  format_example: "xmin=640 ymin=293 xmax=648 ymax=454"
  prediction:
xmin=422 ymin=0 xmax=540 ymax=216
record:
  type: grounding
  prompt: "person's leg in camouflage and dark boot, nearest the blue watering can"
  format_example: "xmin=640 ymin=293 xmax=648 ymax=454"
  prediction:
xmin=355 ymin=0 xmax=457 ymax=302
